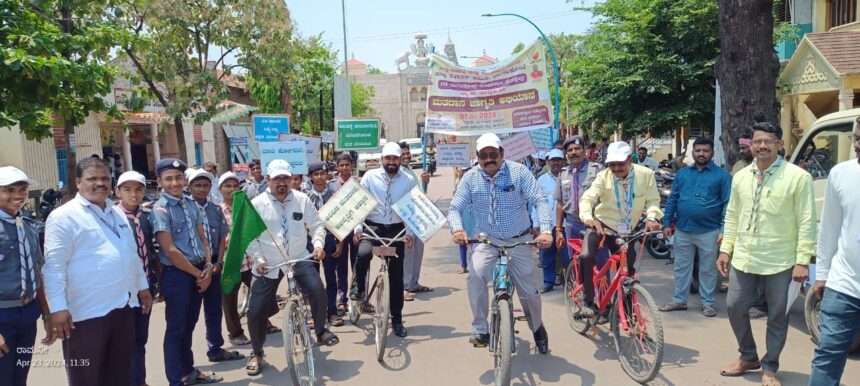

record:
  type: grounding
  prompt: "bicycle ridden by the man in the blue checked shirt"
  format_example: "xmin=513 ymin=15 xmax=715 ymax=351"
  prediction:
xmin=466 ymin=233 xmax=537 ymax=386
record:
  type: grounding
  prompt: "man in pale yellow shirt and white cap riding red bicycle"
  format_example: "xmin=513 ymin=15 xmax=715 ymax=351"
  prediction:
xmin=579 ymin=142 xmax=663 ymax=317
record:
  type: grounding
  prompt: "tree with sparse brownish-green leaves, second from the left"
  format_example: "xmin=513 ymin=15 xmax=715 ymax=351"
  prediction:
xmin=113 ymin=0 xmax=292 ymax=160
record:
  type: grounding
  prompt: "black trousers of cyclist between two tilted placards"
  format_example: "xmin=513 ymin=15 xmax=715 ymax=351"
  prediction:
xmin=353 ymin=221 xmax=406 ymax=324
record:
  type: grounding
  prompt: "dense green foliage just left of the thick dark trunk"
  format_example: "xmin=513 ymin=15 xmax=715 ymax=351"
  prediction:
xmin=557 ymin=0 xmax=719 ymax=136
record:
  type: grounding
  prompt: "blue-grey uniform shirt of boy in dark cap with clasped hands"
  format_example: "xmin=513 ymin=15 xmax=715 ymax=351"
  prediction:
xmin=151 ymin=192 xmax=205 ymax=266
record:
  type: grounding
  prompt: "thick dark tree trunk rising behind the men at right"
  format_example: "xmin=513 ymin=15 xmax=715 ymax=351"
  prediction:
xmin=716 ymin=0 xmax=785 ymax=168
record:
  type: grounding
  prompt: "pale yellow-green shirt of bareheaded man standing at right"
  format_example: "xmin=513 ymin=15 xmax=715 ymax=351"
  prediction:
xmin=720 ymin=161 xmax=816 ymax=275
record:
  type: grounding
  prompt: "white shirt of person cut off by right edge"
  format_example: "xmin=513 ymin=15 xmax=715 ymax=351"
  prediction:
xmin=815 ymin=160 xmax=860 ymax=298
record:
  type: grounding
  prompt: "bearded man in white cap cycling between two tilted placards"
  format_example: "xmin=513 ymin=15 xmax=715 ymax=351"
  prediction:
xmin=349 ymin=142 xmax=418 ymax=338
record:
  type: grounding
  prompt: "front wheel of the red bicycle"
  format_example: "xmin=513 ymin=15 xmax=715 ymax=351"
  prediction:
xmin=610 ymin=283 xmax=663 ymax=384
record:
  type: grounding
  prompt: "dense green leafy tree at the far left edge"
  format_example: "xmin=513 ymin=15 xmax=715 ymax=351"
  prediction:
xmin=0 ymin=0 xmax=119 ymax=193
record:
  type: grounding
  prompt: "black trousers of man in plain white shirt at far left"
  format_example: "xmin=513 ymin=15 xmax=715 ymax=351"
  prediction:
xmin=63 ymin=306 xmax=135 ymax=386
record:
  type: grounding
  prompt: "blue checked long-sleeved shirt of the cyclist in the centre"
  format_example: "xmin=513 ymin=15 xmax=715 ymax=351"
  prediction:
xmin=448 ymin=161 xmax=552 ymax=240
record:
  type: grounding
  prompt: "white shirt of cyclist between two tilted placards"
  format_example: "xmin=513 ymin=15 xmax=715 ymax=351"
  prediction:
xmin=358 ymin=167 xmax=418 ymax=226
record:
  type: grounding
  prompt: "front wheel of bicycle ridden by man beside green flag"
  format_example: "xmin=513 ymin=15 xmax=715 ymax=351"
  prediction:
xmin=281 ymin=301 xmax=315 ymax=386
